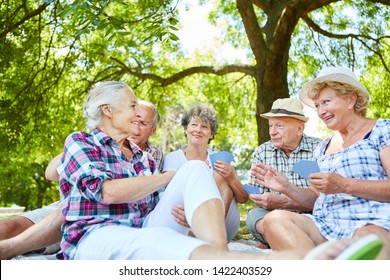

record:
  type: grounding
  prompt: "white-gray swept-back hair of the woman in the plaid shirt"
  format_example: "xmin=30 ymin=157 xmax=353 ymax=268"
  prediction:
xmin=83 ymin=81 xmax=133 ymax=129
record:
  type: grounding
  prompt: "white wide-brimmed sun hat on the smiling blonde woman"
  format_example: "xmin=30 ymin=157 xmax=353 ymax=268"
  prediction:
xmin=299 ymin=67 xmax=370 ymax=108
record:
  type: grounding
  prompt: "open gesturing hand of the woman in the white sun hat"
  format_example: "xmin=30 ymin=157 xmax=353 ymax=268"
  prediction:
xmin=251 ymin=163 xmax=291 ymax=193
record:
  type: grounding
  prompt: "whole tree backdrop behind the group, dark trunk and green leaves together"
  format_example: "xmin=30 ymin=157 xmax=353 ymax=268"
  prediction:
xmin=0 ymin=0 xmax=390 ymax=207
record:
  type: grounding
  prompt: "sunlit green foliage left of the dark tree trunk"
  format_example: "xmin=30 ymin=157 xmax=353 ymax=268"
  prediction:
xmin=0 ymin=1 xmax=256 ymax=209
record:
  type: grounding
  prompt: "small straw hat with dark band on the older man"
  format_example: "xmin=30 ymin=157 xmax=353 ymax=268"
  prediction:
xmin=260 ymin=98 xmax=309 ymax=122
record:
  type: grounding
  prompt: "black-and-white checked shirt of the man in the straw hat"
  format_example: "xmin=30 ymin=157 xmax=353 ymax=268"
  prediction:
xmin=250 ymin=134 xmax=322 ymax=194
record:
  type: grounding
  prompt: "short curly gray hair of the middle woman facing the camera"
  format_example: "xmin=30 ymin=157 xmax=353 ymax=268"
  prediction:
xmin=181 ymin=104 xmax=218 ymax=142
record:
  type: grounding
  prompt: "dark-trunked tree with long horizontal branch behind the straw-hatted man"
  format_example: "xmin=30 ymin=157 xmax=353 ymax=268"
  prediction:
xmin=58 ymin=0 xmax=390 ymax=143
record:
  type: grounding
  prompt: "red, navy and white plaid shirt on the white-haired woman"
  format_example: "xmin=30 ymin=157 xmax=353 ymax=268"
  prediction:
xmin=58 ymin=129 xmax=160 ymax=259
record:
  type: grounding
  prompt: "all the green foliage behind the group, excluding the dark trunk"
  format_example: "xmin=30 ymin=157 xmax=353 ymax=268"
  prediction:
xmin=0 ymin=0 xmax=390 ymax=208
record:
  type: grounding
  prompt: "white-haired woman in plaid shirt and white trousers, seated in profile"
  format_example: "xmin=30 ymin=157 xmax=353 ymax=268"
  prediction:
xmin=58 ymin=82 xmax=227 ymax=259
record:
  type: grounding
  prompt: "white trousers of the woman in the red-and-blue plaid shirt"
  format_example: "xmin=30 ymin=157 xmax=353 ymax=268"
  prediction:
xmin=75 ymin=160 xmax=222 ymax=260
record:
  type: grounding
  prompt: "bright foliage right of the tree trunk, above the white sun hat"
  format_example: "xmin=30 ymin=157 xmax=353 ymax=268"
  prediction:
xmin=289 ymin=1 xmax=390 ymax=82
